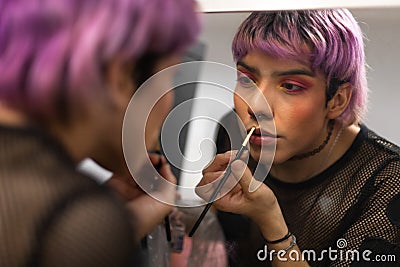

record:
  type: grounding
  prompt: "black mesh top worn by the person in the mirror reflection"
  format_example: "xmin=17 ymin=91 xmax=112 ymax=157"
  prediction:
xmin=217 ymin=112 xmax=400 ymax=266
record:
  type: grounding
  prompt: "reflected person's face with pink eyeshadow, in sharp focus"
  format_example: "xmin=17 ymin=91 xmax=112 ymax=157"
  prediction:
xmin=234 ymin=50 xmax=328 ymax=164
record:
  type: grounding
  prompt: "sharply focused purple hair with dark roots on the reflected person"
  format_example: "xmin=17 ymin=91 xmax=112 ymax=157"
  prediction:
xmin=232 ymin=9 xmax=368 ymax=123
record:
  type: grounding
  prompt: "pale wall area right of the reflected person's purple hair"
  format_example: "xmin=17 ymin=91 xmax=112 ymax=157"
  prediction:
xmin=353 ymin=8 xmax=400 ymax=145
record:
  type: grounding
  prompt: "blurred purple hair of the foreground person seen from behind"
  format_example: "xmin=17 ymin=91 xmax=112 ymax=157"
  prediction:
xmin=0 ymin=0 xmax=200 ymax=122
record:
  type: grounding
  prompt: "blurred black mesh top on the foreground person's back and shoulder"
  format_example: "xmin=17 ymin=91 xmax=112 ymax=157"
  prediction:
xmin=0 ymin=126 xmax=135 ymax=267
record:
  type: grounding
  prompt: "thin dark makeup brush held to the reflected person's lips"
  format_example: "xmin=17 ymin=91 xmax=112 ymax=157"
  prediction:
xmin=189 ymin=127 xmax=256 ymax=237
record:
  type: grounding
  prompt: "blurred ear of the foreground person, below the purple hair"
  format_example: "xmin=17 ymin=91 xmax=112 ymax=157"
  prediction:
xmin=105 ymin=59 xmax=135 ymax=109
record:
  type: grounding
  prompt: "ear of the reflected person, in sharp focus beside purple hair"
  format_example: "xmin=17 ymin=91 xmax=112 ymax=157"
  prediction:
xmin=327 ymin=83 xmax=353 ymax=119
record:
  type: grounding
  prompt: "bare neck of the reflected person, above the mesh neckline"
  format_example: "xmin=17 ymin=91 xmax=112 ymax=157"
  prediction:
xmin=270 ymin=124 xmax=360 ymax=183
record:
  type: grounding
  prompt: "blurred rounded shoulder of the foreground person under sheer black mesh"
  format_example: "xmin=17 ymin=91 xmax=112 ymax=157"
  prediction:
xmin=38 ymin=179 xmax=135 ymax=266
